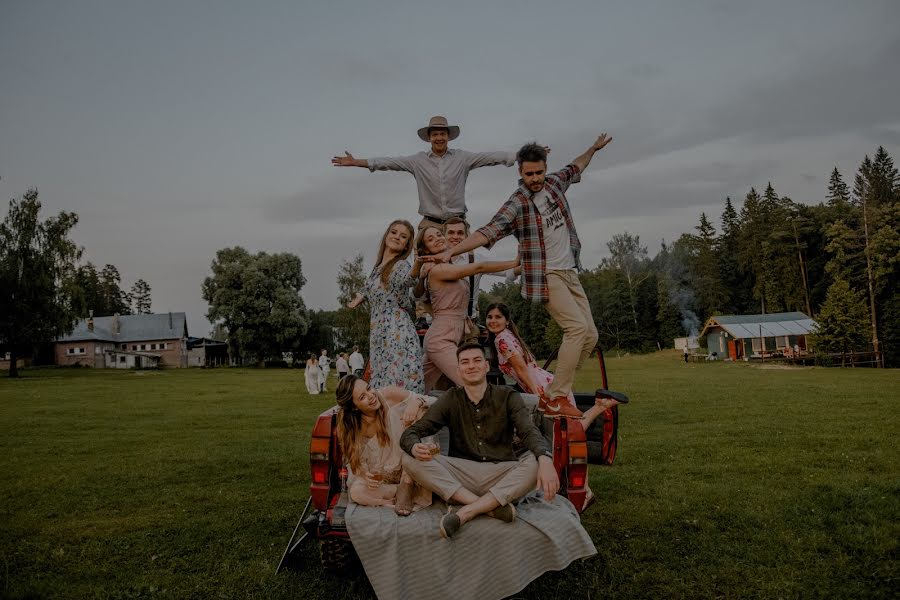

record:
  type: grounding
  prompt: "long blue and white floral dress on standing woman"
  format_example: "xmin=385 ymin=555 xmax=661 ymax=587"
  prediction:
xmin=363 ymin=260 xmax=425 ymax=394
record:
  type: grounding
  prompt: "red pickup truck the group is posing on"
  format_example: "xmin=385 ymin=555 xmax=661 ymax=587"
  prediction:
xmin=276 ymin=346 xmax=627 ymax=573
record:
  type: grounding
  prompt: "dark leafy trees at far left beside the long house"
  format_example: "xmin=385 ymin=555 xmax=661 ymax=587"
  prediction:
xmin=0 ymin=188 xmax=152 ymax=377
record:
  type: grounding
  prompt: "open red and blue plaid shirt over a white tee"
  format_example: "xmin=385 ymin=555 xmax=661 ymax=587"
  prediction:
xmin=478 ymin=165 xmax=581 ymax=302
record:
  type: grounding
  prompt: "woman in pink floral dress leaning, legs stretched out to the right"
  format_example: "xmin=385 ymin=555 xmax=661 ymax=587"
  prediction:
xmin=486 ymin=302 xmax=619 ymax=430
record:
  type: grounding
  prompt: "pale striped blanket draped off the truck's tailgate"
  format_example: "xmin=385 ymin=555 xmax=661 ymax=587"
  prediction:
xmin=347 ymin=493 xmax=597 ymax=600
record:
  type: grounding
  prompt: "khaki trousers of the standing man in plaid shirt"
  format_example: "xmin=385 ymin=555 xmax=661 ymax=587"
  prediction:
xmin=545 ymin=270 xmax=598 ymax=399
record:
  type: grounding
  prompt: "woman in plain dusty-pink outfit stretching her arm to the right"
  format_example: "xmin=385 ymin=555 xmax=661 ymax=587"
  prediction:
xmin=416 ymin=227 xmax=519 ymax=393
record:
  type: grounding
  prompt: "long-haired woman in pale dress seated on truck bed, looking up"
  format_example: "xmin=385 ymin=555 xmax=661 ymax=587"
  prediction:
xmin=335 ymin=375 xmax=435 ymax=516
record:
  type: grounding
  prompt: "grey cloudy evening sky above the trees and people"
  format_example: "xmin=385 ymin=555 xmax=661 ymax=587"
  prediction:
xmin=0 ymin=0 xmax=900 ymax=335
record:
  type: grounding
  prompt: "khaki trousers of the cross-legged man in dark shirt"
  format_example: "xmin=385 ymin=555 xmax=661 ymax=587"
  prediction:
xmin=402 ymin=452 xmax=537 ymax=506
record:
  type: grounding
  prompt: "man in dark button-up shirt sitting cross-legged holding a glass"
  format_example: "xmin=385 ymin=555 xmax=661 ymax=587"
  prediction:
xmin=400 ymin=343 xmax=559 ymax=538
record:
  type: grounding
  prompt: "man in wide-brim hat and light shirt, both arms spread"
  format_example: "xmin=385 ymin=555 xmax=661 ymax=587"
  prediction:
xmin=331 ymin=116 xmax=516 ymax=229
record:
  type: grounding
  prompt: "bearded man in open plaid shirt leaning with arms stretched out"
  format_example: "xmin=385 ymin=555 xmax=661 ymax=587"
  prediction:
xmin=433 ymin=133 xmax=612 ymax=417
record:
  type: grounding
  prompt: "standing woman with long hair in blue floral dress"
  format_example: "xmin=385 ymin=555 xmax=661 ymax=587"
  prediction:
xmin=347 ymin=219 xmax=425 ymax=394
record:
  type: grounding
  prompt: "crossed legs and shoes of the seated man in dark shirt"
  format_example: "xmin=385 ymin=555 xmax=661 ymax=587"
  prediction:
xmin=403 ymin=452 xmax=538 ymax=537
